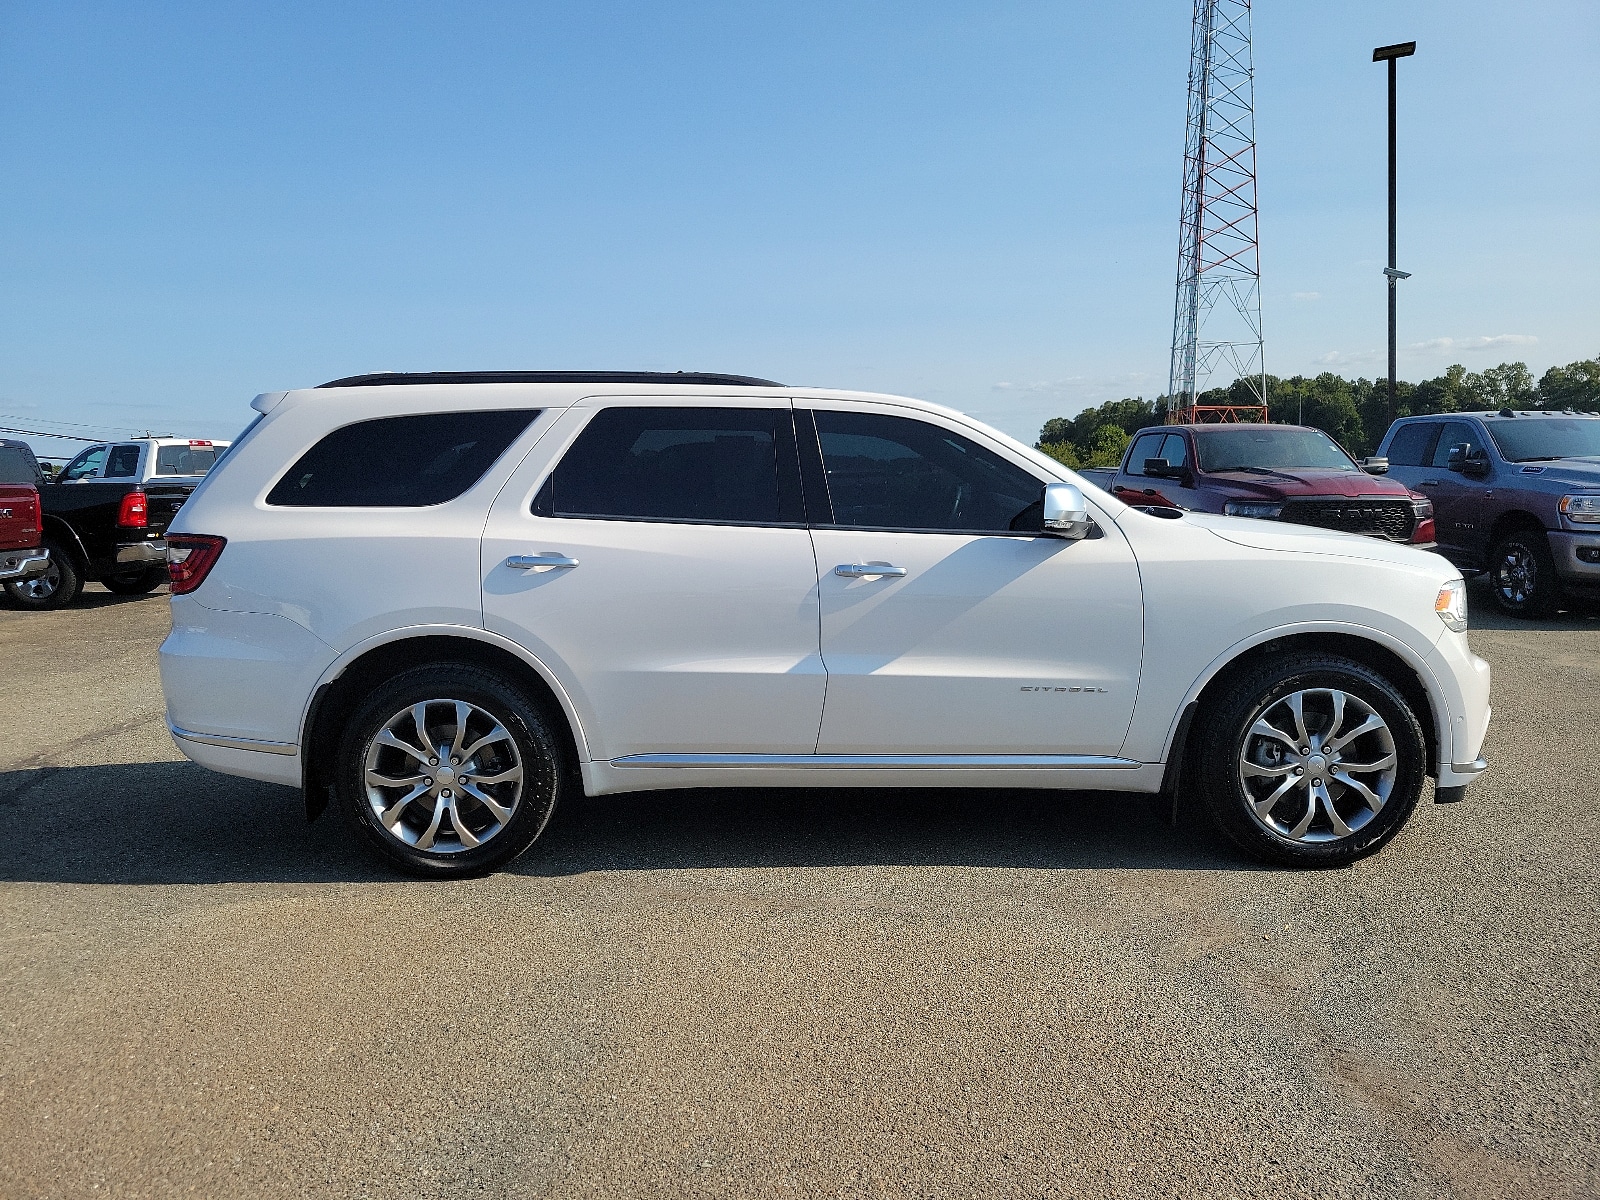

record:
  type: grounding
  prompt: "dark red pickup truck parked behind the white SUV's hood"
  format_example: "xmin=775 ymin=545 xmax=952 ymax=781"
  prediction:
xmin=1082 ymin=424 xmax=1434 ymax=549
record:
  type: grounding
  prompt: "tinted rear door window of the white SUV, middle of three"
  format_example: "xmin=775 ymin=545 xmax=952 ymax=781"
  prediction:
xmin=534 ymin=408 xmax=805 ymax=525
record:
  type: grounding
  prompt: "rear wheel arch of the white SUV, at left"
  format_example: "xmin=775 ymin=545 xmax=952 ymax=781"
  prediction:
xmin=301 ymin=626 xmax=589 ymax=821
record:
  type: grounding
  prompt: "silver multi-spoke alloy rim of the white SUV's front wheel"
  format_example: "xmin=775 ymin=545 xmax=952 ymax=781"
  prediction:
xmin=1238 ymin=688 xmax=1398 ymax=843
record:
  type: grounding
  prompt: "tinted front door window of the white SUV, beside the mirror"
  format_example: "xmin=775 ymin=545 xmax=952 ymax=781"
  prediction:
xmin=816 ymin=411 xmax=1045 ymax=533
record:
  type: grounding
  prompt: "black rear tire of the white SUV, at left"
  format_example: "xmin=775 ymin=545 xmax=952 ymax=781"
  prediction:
xmin=334 ymin=662 xmax=568 ymax=878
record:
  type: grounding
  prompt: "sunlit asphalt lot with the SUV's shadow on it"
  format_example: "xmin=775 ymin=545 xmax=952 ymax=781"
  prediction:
xmin=0 ymin=589 xmax=1600 ymax=1198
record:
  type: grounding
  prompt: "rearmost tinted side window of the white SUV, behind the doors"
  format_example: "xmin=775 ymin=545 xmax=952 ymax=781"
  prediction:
xmin=267 ymin=410 xmax=539 ymax=509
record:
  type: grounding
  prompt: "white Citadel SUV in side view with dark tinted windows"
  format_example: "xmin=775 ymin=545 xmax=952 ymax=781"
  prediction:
xmin=162 ymin=373 xmax=1490 ymax=875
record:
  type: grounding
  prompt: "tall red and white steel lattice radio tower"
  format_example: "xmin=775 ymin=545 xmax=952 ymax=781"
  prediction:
xmin=1166 ymin=0 xmax=1267 ymax=424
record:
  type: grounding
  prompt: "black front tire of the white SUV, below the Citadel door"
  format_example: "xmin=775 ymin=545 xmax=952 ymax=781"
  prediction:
xmin=1197 ymin=654 xmax=1427 ymax=867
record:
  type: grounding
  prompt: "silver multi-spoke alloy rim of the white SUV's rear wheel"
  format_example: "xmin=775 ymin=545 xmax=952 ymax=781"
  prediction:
xmin=365 ymin=699 xmax=523 ymax=854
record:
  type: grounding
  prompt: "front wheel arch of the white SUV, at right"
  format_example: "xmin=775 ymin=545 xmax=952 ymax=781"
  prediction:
xmin=1163 ymin=626 xmax=1450 ymax=774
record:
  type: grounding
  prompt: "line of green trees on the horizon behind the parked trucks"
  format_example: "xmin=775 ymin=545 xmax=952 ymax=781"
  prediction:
xmin=1038 ymin=355 xmax=1600 ymax=467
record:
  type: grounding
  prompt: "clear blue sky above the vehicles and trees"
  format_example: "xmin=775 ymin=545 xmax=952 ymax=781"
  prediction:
xmin=0 ymin=0 xmax=1600 ymax=464
